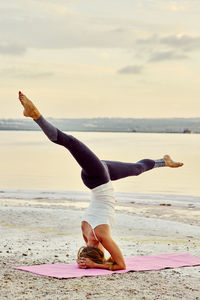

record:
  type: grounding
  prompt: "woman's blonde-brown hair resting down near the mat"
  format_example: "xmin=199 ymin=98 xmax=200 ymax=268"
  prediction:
xmin=77 ymin=246 xmax=114 ymax=264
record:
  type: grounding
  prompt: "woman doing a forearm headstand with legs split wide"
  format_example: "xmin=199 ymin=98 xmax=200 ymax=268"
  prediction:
xmin=19 ymin=92 xmax=183 ymax=270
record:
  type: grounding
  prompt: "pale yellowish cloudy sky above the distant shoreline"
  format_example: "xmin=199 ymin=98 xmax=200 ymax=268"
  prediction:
xmin=0 ymin=0 xmax=200 ymax=118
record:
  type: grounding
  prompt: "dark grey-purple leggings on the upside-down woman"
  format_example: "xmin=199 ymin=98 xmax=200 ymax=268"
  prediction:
xmin=35 ymin=116 xmax=155 ymax=189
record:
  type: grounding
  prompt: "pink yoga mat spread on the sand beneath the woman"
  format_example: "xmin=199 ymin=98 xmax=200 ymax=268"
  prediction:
xmin=14 ymin=254 xmax=200 ymax=279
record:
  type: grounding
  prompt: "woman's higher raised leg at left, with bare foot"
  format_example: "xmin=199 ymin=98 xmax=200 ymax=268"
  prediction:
xmin=20 ymin=94 xmax=110 ymax=188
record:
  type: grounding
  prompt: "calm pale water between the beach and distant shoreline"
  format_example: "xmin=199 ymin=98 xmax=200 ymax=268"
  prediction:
xmin=0 ymin=131 xmax=200 ymax=201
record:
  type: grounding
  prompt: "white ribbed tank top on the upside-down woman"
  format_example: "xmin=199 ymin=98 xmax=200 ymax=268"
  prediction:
xmin=83 ymin=181 xmax=115 ymax=228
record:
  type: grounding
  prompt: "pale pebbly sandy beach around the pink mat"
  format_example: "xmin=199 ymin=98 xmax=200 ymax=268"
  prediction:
xmin=0 ymin=199 xmax=200 ymax=300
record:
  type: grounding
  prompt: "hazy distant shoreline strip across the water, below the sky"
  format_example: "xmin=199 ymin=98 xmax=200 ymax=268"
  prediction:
xmin=0 ymin=118 xmax=200 ymax=133
